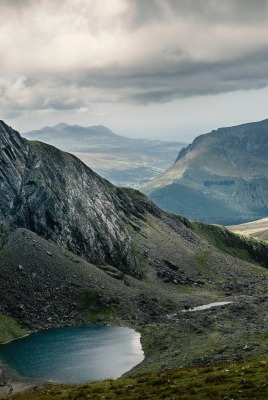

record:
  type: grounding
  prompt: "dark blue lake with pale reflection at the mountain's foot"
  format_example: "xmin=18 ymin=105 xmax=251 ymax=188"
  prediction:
xmin=0 ymin=325 xmax=144 ymax=383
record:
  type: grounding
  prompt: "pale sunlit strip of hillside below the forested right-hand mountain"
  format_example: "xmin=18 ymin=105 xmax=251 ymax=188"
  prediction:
xmin=228 ymin=218 xmax=268 ymax=242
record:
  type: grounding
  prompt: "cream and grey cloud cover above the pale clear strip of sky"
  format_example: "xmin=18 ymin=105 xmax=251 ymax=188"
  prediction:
xmin=0 ymin=0 xmax=268 ymax=115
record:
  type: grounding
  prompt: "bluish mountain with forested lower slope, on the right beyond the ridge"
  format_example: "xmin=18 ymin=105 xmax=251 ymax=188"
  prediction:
xmin=141 ymin=120 xmax=268 ymax=225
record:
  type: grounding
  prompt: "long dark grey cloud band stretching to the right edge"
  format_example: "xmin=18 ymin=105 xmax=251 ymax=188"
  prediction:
xmin=61 ymin=43 xmax=268 ymax=104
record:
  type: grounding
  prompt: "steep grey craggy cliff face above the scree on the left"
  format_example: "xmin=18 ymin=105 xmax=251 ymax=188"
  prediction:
xmin=0 ymin=122 xmax=147 ymax=277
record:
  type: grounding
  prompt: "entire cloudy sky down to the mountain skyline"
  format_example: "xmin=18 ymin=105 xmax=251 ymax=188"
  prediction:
xmin=0 ymin=0 xmax=268 ymax=141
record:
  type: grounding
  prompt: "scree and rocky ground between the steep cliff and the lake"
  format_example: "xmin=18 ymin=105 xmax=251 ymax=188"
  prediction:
xmin=0 ymin=228 xmax=268 ymax=384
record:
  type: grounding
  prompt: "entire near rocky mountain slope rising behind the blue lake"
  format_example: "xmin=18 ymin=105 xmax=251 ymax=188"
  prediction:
xmin=0 ymin=122 xmax=268 ymax=383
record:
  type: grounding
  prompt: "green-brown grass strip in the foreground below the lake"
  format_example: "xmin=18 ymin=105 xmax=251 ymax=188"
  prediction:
xmin=9 ymin=357 xmax=268 ymax=400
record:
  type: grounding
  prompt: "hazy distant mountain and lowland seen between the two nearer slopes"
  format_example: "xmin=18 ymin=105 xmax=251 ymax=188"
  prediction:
xmin=23 ymin=123 xmax=185 ymax=187
